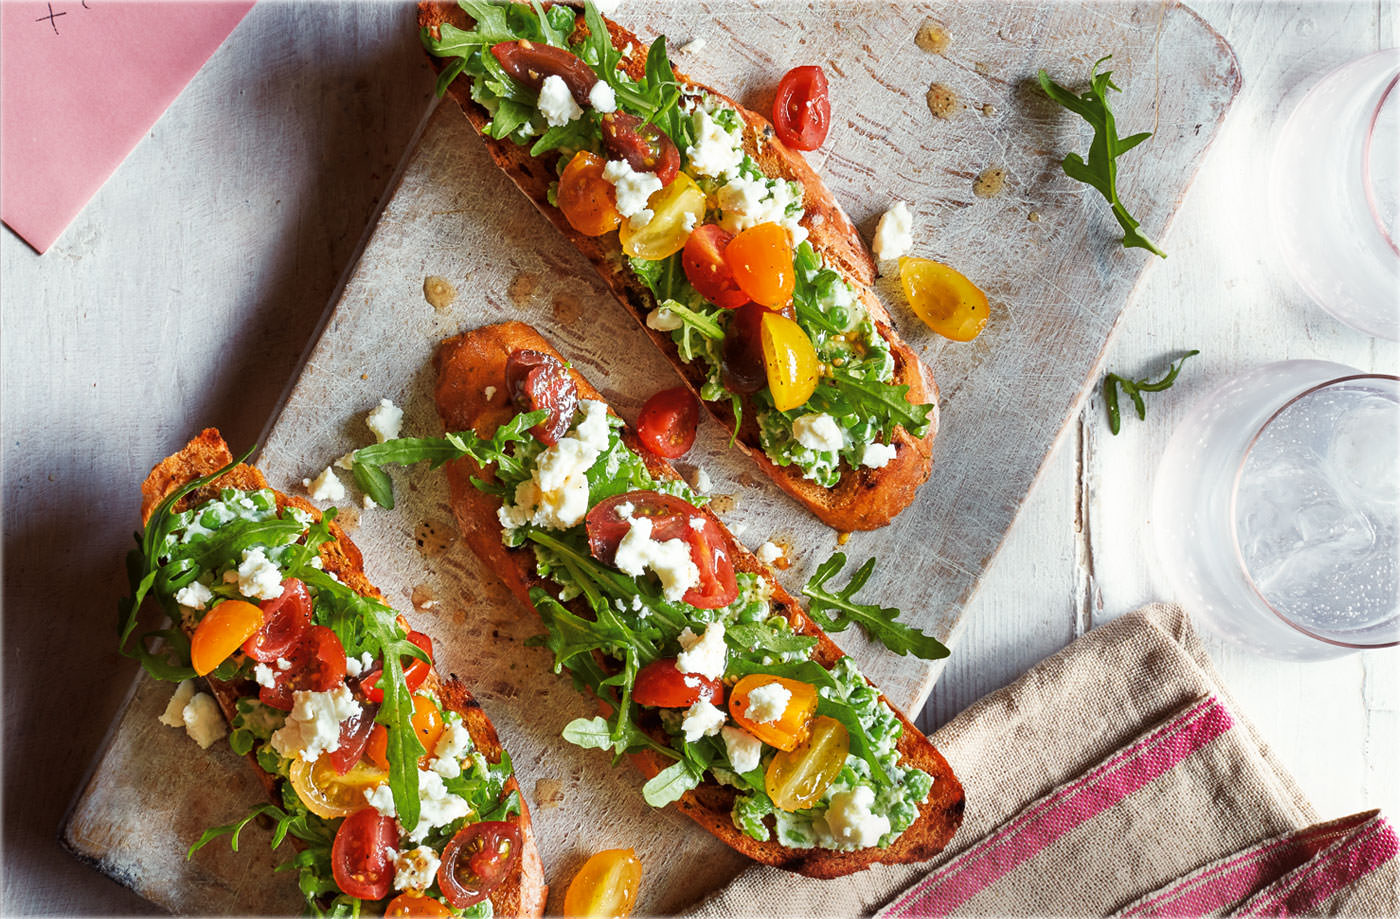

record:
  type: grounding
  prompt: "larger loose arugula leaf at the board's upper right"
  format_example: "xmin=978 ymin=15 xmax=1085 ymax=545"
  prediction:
xmin=1039 ymin=55 xmax=1166 ymax=258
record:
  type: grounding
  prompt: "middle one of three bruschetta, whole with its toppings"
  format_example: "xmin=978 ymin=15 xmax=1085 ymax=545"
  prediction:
xmin=353 ymin=322 xmax=963 ymax=877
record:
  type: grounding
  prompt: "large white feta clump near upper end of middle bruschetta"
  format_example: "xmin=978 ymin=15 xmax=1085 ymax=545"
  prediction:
xmin=497 ymin=399 xmax=608 ymax=530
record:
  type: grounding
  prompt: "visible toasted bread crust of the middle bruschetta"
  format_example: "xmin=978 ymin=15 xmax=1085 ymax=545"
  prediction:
xmin=434 ymin=322 xmax=963 ymax=878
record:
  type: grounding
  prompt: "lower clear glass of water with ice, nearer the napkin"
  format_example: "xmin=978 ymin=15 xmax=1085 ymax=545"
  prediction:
xmin=1152 ymin=360 xmax=1400 ymax=660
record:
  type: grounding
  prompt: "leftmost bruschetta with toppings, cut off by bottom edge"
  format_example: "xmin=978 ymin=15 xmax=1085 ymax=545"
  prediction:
xmin=120 ymin=429 xmax=546 ymax=919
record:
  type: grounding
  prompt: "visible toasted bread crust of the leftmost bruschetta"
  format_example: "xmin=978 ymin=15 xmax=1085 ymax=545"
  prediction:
xmin=141 ymin=427 xmax=549 ymax=916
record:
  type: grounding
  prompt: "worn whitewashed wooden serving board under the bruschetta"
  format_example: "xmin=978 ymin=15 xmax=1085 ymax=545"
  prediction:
xmin=64 ymin=0 xmax=1239 ymax=913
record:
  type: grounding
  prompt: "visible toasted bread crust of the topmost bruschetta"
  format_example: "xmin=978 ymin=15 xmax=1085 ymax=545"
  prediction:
xmin=419 ymin=3 xmax=938 ymax=531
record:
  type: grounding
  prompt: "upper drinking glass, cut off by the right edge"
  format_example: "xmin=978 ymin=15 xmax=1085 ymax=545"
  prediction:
xmin=1270 ymin=48 xmax=1400 ymax=340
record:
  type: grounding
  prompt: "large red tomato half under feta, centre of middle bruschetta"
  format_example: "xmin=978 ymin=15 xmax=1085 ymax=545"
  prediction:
xmin=584 ymin=492 xmax=739 ymax=609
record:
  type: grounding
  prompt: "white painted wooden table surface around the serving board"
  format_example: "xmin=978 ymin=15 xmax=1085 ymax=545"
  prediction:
xmin=0 ymin=0 xmax=1400 ymax=915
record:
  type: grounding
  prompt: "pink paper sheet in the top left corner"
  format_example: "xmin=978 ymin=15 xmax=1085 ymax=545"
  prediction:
xmin=0 ymin=0 xmax=253 ymax=252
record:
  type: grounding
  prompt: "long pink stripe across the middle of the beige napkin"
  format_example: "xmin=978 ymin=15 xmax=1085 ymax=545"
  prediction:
xmin=879 ymin=696 xmax=1233 ymax=919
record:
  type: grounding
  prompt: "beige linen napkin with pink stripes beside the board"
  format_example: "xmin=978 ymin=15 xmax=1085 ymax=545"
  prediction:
xmin=690 ymin=605 xmax=1400 ymax=919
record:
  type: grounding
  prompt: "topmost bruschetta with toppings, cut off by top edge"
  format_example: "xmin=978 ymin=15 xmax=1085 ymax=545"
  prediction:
xmin=419 ymin=0 xmax=938 ymax=531
